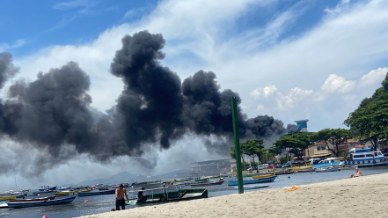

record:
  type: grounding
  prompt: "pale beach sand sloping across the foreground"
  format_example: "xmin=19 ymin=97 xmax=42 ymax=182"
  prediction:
xmin=77 ymin=171 xmax=388 ymax=218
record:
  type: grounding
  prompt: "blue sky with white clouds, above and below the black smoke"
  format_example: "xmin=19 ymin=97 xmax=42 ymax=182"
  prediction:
xmin=0 ymin=0 xmax=388 ymax=189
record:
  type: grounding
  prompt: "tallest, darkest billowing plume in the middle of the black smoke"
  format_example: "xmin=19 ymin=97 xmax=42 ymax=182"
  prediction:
xmin=111 ymin=31 xmax=183 ymax=151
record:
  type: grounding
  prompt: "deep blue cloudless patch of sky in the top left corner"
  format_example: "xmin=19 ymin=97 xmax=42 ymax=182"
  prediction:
xmin=0 ymin=0 xmax=157 ymax=56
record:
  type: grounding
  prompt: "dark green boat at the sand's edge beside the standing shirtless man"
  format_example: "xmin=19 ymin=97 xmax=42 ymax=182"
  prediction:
xmin=126 ymin=188 xmax=208 ymax=205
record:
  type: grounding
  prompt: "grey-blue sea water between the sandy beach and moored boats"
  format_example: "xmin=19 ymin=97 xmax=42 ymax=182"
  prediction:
xmin=0 ymin=166 xmax=388 ymax=218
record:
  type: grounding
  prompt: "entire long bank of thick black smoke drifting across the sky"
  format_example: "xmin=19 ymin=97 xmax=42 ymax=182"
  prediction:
xmin=0 ymin=31 xmax=291 ymax=175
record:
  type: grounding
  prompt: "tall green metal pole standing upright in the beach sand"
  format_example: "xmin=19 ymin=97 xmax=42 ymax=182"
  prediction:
xmin=232 ymin=97 xmax=244 ymax=194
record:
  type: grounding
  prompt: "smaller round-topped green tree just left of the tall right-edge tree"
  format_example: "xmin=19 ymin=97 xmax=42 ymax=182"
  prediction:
xmin=312 ymin=128 xmax=352 ymax=157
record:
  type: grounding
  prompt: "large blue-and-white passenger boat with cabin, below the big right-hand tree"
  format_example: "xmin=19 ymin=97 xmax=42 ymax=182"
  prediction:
xmin=343 ymin=148 xmax=387 ymax=167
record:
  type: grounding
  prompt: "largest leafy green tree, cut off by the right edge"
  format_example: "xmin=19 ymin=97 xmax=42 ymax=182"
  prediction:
xmin=344 ymin=71 xmax=388 ymax=150
